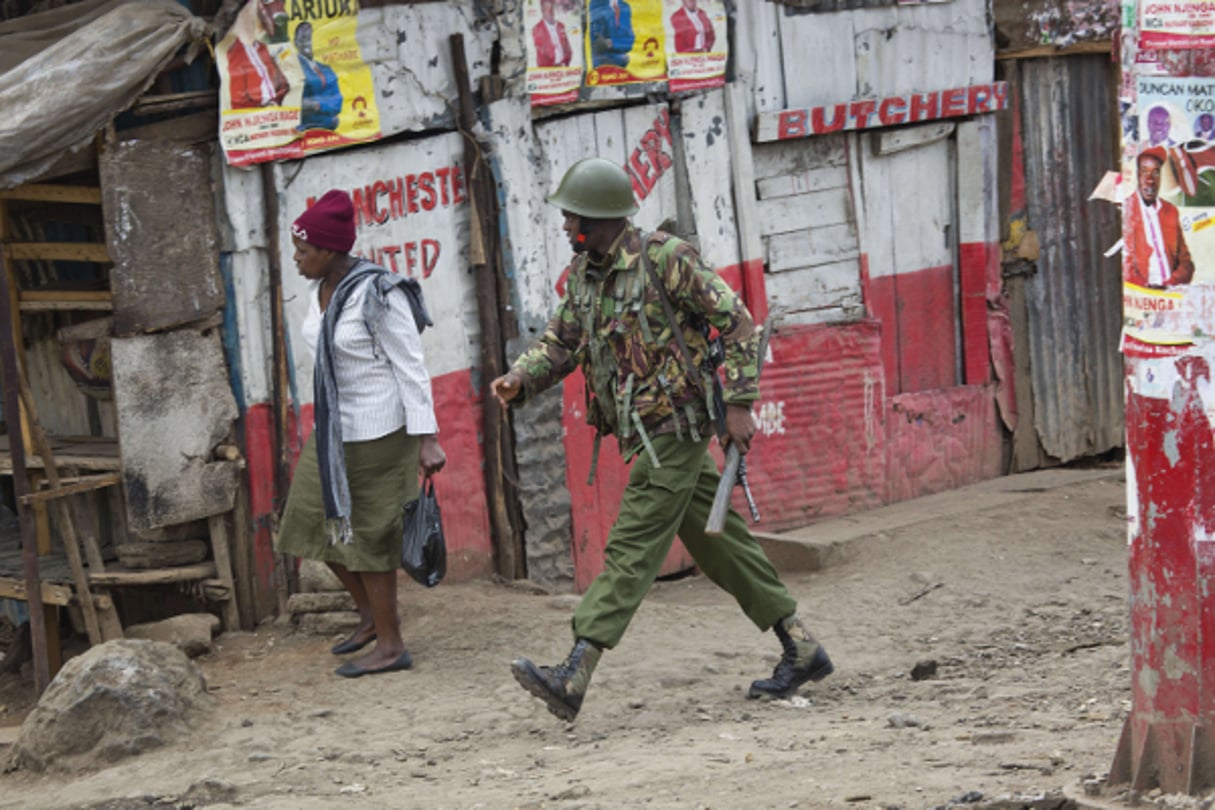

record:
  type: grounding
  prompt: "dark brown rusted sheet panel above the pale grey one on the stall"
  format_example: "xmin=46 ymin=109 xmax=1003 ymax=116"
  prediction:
xmin=101 ymin=141 xmax=225 ymax=335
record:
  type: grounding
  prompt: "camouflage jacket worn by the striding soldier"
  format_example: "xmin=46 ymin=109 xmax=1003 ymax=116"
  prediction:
xmin=512 ymin=225 xmax=759 ymax=460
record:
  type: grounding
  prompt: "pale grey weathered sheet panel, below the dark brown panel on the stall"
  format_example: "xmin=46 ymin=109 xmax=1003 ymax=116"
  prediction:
xmin=111 ymin=328 xmax=239 ymax=531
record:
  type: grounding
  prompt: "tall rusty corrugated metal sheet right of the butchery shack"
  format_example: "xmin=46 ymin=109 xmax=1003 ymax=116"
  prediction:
xmin=1019 ymin=56 xmax=1124 ymax=461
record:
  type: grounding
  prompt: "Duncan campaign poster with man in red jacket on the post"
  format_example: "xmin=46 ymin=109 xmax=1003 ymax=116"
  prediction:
xmin=1123 ymin=77 xmax=1215 ymax=356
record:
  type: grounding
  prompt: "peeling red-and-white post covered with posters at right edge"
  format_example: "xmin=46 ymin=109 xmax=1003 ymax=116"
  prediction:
xmin=1109 ymin=0 xmax=1215 ymax=795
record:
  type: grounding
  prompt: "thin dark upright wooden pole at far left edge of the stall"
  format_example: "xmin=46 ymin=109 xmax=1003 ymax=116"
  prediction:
xmin=0 ymin=244 xmax=51 ymax=695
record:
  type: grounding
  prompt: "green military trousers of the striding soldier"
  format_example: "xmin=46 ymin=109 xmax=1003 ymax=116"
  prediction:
xmin=573 ymin=434 xmax=797 ymax=648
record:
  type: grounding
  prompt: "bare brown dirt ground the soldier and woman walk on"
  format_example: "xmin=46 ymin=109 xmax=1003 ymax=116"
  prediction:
xmin=0 ymin=468 xmax=1185 ymax=810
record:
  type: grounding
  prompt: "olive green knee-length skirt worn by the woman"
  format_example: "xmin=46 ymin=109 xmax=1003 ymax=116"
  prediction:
xmin=275 ymin=427 xmax=422 ymax=571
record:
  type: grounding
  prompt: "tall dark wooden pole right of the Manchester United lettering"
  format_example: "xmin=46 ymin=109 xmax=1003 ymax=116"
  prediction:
xmin=450 ymin=34 xmax=527 ymax=579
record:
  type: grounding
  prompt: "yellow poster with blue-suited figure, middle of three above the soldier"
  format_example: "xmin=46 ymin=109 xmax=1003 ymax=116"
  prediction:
xmin=584 ymin=0 xmax=667 ymax=87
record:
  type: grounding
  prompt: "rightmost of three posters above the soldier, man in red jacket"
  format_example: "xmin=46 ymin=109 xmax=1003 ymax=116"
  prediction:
xmin=662 ymin=0 xmax=729 ymax=92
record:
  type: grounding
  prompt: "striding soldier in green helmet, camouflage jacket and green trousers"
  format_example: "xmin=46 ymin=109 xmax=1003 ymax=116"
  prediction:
xmin=492 ymin=158 xmax=832 ymax=721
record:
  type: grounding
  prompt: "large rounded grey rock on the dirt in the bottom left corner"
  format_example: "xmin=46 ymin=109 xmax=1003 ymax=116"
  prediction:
xmin=11 ymin=639 xmax=214 ymax=771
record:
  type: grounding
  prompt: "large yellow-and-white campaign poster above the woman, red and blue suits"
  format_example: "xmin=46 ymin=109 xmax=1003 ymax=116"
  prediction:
xmin=215 ymin=0 xmax=380 ymax=166
